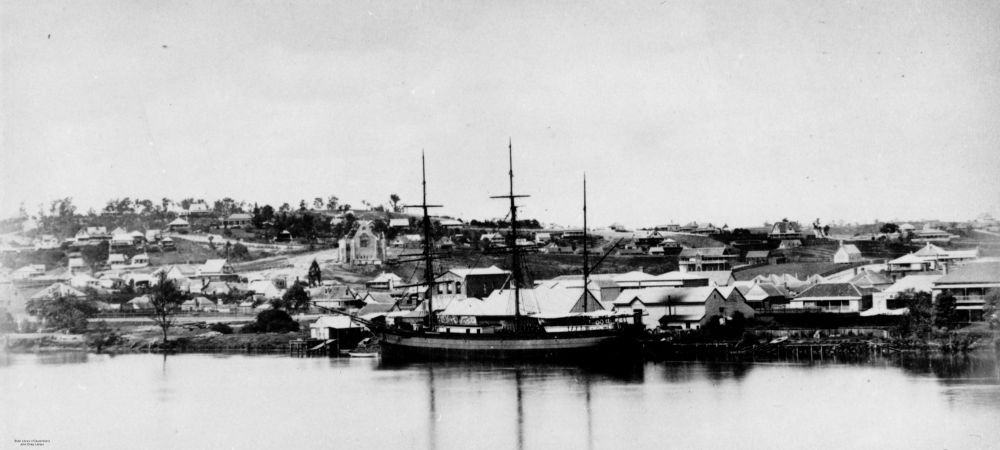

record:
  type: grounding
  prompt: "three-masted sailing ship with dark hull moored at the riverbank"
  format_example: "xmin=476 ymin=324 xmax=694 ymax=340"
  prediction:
xmin=368 ymin=143 xmax=642 ymax=359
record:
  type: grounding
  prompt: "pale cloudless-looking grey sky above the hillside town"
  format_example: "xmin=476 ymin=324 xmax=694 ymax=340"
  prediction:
xmin=0 ymin=0 xmax=1000 ymax=227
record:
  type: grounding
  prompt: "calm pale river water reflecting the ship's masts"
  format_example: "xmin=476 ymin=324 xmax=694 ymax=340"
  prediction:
xmin=0 ymin=353 xmax=1000 ymax=449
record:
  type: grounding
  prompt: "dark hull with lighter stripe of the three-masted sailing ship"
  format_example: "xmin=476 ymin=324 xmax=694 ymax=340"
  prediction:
xmin=376 ymin=329 xmax=634 ymax=360
